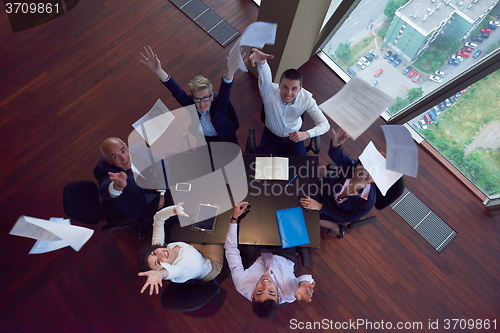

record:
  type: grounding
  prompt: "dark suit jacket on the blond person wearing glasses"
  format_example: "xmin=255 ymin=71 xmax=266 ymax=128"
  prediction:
xmin=162 ymin=77 xmax=238 ymax=144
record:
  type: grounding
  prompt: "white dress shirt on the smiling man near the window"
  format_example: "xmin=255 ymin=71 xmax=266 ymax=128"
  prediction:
xmin=257 ymin=61 xmax=330 ymax=138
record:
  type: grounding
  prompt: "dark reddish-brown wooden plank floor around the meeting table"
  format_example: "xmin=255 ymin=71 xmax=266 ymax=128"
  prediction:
xmin=0 ymin=0 xmax=500 ymax=332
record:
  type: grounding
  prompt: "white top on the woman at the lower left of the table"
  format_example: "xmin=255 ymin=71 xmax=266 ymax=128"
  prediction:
xmin=151 ymin=206 xmax=212 ymax=283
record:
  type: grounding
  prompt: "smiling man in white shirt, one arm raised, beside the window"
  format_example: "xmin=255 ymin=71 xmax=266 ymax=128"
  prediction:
xmin=249 ymin=48 xmax=330 ymax=155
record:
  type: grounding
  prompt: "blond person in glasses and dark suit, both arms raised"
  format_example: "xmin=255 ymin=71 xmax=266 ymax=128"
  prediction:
xmin=139 ymin=46 xmax=239 ymax=144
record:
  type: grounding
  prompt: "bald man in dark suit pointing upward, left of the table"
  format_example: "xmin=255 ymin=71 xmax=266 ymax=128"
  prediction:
xmin=94 ymin=137 xmax=166 ymax=222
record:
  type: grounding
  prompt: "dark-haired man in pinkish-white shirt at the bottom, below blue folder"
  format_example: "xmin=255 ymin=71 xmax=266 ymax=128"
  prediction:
xmin=224 ymin=202 xmax=315 ymax=318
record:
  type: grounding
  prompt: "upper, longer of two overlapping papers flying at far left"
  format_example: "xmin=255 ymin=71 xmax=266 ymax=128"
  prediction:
xmin=9 ymin=216 xmax=94 ymax=251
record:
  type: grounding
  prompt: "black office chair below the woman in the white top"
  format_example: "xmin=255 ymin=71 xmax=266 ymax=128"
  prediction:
xmin=161 ymin=279 xmax=220 ymax=312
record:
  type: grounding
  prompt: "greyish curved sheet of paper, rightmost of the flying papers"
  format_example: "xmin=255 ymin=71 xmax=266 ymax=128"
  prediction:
xmin=381 ymin=125 xmax=418 ymax=177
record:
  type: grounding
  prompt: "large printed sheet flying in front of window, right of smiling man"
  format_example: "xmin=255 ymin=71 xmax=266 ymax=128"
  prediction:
xmin=319 ymin=77 xmax=396 ymax=140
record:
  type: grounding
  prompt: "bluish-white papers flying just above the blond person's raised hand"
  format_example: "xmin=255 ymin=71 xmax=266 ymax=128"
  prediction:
xmin=229 ymin=22 xmax=278 ymax=73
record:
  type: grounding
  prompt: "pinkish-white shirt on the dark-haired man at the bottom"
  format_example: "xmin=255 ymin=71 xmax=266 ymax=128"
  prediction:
xmin=224 ymin=223 xmax=314 ymax=304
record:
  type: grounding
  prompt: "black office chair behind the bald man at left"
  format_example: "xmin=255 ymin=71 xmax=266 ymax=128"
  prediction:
xmin=63 ymin=180 xmax=143 ymax=239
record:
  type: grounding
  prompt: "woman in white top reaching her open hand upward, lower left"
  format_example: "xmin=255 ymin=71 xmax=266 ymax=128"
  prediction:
xmin=139 ymin=202 xmax=224 ymax=295
